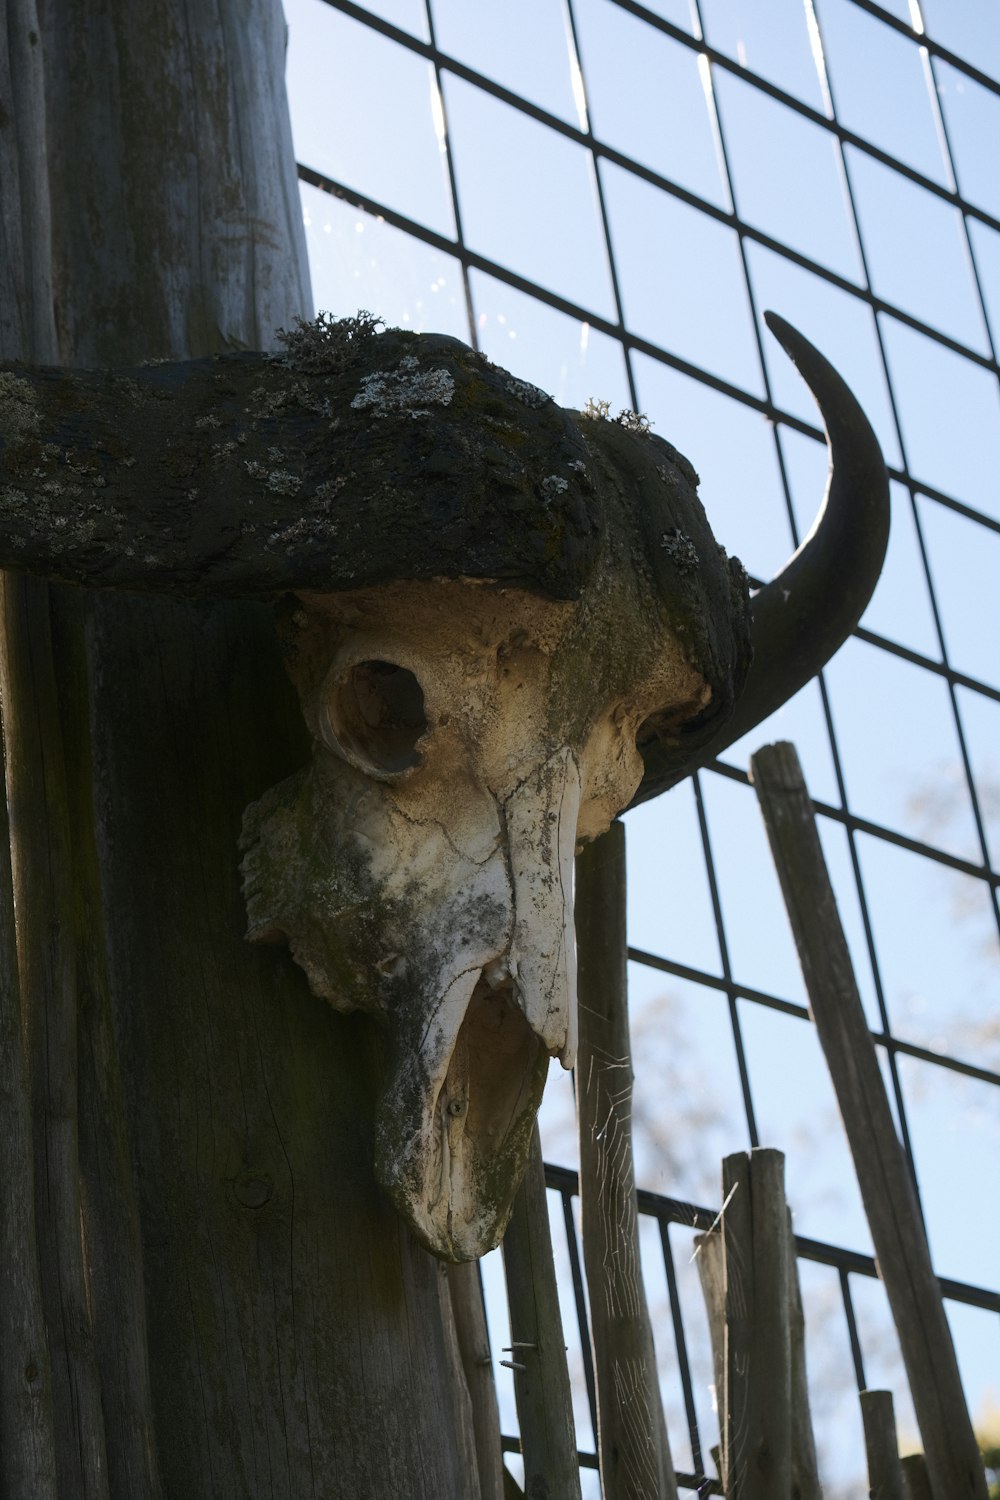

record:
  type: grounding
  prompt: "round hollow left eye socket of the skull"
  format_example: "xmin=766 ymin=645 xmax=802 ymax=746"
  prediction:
xmin=321 ymin=662 xmax=427 ymax=776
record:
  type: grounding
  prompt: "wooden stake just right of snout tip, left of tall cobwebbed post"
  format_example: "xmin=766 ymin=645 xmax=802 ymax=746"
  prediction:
xmin=504 ymin=1127 xmax=580 ymax=1500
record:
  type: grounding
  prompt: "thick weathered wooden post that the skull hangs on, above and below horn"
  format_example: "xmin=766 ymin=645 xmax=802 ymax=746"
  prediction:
xmin=0 ymin=0 xmax=485 ymax=1500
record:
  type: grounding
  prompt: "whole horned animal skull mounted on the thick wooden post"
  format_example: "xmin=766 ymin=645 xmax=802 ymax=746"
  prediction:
xmin=0 ymin=314 xmax=889 ymax=1259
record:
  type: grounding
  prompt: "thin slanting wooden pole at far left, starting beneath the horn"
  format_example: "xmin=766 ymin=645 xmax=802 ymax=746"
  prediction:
xmin=1 ymin=578 xmax=109 ymax=1500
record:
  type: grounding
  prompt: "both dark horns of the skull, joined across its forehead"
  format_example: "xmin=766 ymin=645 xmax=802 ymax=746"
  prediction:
xmin=0 ymin=314 xmax=889 ymax=803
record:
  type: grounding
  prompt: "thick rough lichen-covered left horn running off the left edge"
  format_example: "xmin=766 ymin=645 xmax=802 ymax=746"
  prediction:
xmin=0 ymin=315 xmax=598 ymax=599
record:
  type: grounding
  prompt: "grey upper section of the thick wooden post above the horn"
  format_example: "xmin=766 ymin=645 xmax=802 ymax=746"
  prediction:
xmin=39 ymin=0 xmax=312 ymax=366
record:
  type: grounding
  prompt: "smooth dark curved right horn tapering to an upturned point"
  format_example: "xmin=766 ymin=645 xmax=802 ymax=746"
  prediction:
xmin=633 ymin=312 xmax=889 ymax=806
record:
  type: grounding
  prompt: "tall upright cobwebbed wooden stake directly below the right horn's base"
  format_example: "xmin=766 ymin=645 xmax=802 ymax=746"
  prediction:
xmin=576 ymin=822 xmax=676 ymax=1500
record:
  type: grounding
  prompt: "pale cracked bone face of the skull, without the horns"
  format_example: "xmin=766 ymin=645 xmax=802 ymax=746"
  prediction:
xmin=244 ymin=576 xmax=708 ymax=1260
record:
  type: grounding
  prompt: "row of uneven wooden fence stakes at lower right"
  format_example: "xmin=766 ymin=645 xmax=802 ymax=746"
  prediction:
xmin=482 ymin=744 xmax=988 ymax=1500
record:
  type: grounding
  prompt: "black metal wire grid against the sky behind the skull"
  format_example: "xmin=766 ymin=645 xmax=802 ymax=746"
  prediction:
xmin=289 ymin=0 xmax=1000 ymax=1494
